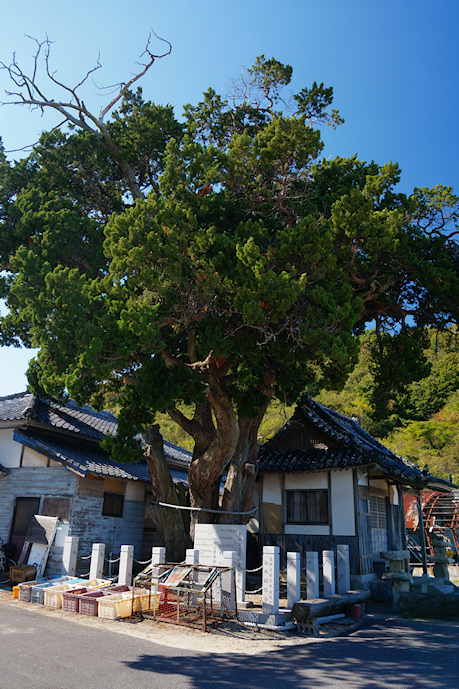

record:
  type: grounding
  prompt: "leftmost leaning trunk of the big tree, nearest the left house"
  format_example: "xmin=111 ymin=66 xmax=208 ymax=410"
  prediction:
xmin=145 ymin=426 xmax=190 ymax=562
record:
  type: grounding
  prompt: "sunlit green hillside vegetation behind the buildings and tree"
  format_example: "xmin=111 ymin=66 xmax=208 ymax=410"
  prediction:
xmin=157 ymin=329 xmax=459 ymax=482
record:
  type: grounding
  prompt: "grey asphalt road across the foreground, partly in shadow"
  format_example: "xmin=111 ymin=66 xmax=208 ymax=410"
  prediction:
xmin=0 ymin=605 xmax=459 ymax=689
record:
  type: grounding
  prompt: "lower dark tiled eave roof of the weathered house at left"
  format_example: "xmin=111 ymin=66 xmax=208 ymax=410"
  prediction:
xmin=14 ymin=429 xmax=187 ymax=483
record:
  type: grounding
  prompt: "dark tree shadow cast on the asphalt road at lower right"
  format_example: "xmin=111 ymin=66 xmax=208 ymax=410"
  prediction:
xmin=122 ymin=620 xmax=459 ymax=689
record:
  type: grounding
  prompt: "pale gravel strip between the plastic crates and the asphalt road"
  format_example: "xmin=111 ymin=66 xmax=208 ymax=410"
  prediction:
xmin=0 ymin=591 xmax=320 ymax=655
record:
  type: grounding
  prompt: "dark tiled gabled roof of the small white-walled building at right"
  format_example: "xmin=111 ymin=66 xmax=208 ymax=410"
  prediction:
xmin=259 ymin=395 xmax=454 ymax=489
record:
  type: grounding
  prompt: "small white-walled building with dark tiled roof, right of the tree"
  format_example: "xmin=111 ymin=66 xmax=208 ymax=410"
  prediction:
xmin=256 ymin=395 xmax=455 ymax=587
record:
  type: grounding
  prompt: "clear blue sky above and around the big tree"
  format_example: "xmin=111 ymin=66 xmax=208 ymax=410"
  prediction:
xmin=0 ymin=0 xmax=459 ymax=396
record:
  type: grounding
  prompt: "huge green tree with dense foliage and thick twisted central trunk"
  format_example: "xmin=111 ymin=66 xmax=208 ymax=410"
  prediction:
xmin=0 ymin=48 xmax=458 ymax=552
